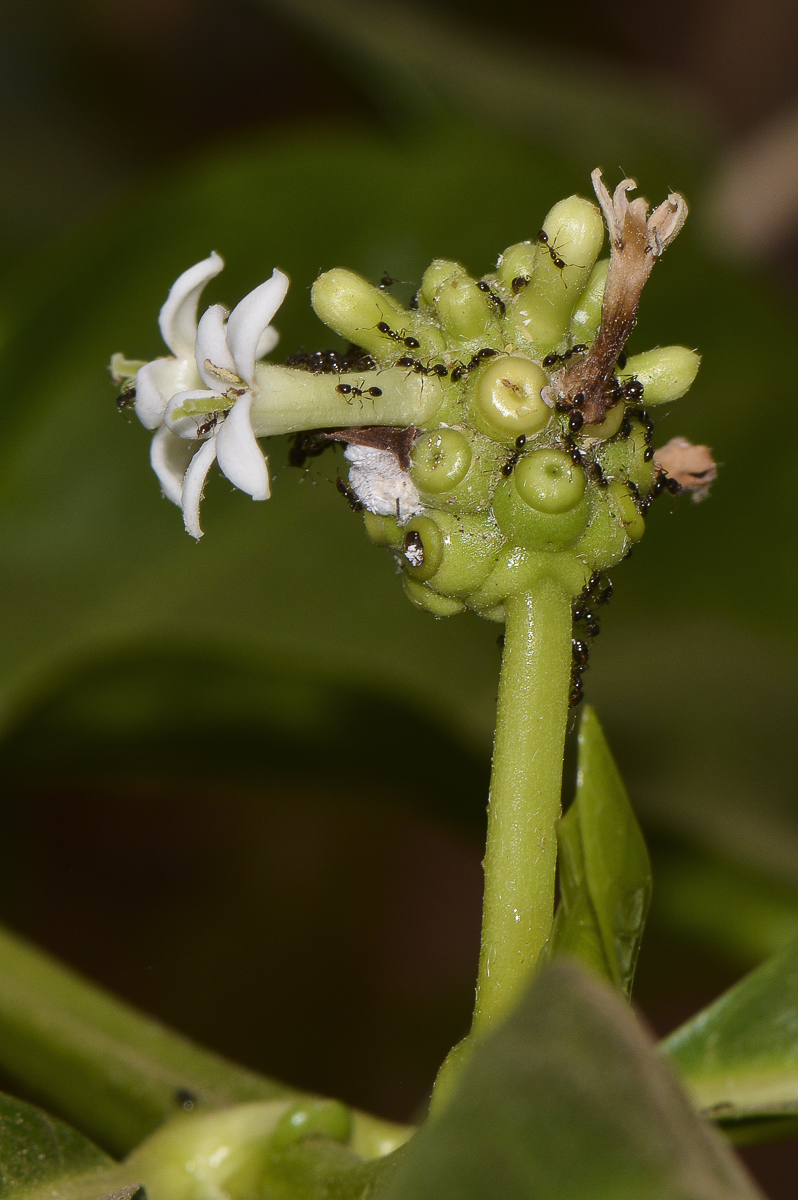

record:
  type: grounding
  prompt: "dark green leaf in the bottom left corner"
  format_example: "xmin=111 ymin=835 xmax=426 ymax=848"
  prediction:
xmin=0 ymin=1092 xmax=121 ymax=1200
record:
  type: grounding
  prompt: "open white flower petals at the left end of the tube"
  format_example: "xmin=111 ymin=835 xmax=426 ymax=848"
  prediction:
xmin=129 ymin=253 xmax=288 ymax=538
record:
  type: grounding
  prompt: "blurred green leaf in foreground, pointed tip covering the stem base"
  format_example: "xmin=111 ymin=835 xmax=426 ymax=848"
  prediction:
xmin=377 ymin=961 xmax=758 ymax=1200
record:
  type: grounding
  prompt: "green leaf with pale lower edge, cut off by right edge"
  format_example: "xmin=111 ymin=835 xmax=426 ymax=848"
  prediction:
xmin=661 ymin=940 xmax=798 ymax=1140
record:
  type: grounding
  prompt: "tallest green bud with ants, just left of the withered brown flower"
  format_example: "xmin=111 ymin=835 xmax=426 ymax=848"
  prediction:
xmin=512 ymin=196 xmax=604 ymax=352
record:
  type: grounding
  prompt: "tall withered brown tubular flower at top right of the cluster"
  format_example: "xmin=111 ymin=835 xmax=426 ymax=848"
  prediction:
xmin=554 ymin=169 xmax=688 ymax=425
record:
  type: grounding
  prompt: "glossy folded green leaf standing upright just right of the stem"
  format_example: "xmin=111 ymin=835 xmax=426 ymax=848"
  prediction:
xmin=552 ymin=708 xmax=652 ymax=995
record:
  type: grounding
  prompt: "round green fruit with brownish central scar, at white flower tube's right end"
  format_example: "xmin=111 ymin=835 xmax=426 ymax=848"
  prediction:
xmin=474 ymin=355 xmax=552 ymax=444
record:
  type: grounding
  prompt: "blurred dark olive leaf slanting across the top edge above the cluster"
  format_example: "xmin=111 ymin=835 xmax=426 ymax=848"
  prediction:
xmin=257 ymin=0 xmax=714 ymax=182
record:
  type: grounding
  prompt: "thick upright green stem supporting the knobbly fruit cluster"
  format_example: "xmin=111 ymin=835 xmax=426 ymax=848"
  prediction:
xmin=474 ymin=578 xmax=571 ymax=1033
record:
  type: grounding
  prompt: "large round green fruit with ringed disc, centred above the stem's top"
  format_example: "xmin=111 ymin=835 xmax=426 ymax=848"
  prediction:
xmin=493 ymin=449 xmax=590 ymax=550
